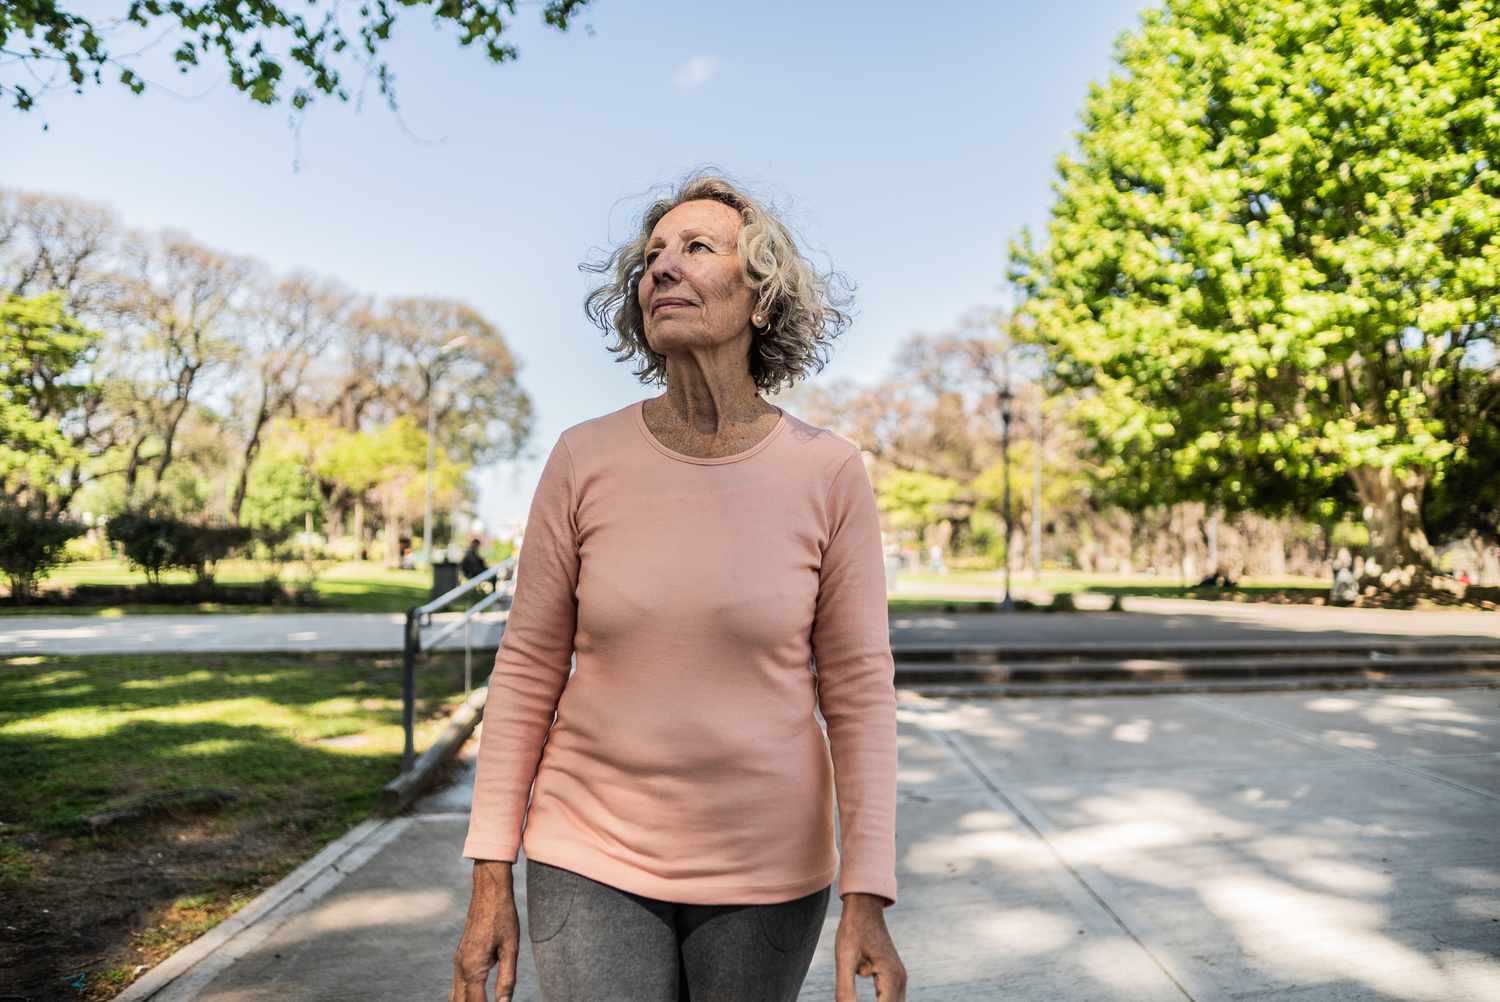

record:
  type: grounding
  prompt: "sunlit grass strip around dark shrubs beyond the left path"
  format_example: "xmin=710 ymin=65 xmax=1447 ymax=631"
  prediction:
xmin=0 ymin=560 xmax=432 ymax=617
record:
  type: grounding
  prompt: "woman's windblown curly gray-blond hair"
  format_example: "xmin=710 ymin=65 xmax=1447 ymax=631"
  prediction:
xmin=579 ymin=168 xmax=854 ymax=390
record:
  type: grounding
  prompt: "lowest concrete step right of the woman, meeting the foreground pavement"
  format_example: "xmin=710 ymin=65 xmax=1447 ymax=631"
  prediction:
xmin=896 ymin=669 xmax=1500 ymax=699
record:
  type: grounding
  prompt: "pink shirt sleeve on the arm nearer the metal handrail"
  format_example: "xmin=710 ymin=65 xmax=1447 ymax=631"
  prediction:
xmin=464 ymin=437 xmax=579 ymax=863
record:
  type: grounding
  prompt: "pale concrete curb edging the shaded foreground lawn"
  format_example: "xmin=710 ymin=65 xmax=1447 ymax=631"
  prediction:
xmin=114 ymin=818 xmax=414 ymax=1002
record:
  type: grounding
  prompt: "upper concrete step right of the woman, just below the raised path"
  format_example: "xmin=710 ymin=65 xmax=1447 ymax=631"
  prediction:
xmin=896 ymin=650 xmax=1500 ymax=686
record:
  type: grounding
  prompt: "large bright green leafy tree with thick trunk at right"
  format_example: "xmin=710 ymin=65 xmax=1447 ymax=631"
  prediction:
xmin=1011 ymin=0 xmax=1500 ymax=582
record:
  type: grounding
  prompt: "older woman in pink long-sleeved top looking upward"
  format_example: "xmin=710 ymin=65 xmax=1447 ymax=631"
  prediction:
xmin=450 ymin=174 xmax=906 ymax=1002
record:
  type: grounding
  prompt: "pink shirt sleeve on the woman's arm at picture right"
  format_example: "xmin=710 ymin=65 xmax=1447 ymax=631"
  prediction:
xmin=812 ymin=453 xmax=897 ymax=908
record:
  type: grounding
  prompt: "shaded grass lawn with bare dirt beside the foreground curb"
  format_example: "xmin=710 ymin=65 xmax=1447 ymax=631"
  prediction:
xmin=0 ymin=653 xmax=477 ymax=999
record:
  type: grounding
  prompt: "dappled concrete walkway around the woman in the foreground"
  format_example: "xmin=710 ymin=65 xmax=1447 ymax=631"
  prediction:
xmin=128 ymin=689 xmax=1500 ymax=1002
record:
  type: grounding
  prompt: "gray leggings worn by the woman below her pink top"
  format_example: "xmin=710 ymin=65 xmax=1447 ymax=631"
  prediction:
xmin=527 ymin=860 xmax=833 ymax=1002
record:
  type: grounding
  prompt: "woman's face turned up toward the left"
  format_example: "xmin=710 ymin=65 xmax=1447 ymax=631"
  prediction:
xmin=638 ymin=200 xmax=756 ymax=354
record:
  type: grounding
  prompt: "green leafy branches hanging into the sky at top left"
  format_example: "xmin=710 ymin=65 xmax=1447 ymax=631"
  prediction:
xmin=0 ymin=0 xmax=588 ymax=125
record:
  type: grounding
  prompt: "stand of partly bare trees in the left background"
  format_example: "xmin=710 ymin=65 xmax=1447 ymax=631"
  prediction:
xmin=0 ymin=188 xmax=510 ymax=540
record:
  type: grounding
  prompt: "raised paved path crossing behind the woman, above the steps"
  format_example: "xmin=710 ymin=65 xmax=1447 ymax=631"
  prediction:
xmin=0 ymin=599 xmax=1500 ymax=654
